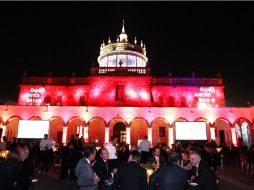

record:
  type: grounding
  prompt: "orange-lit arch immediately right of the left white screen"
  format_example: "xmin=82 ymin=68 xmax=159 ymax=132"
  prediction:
xmin=49 ymin=116 xmax=65 ymax=143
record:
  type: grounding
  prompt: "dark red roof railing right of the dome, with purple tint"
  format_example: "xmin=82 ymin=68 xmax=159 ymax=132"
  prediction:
xmin=152 ymin=77 xmax=223 ymax=86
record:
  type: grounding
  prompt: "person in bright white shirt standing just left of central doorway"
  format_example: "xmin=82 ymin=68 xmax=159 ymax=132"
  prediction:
xmin=104 ymin=136 xmax=118 ymax=171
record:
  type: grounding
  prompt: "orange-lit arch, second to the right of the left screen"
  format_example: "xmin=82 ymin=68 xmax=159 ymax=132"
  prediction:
xmin=66 ymin=116 xmax=86 ymax=139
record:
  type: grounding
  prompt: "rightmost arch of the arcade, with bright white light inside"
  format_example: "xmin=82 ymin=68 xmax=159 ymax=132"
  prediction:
xmin=233 ymin=117 xmax=253 ymax=146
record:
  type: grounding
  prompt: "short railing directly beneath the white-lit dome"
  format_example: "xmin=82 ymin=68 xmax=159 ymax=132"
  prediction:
xmin=90 ymin=67 xmax=150 ymax=75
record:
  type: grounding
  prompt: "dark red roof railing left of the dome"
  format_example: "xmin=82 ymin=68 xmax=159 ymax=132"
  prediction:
xmin=21 ymin=77 xmax=90 ymax=85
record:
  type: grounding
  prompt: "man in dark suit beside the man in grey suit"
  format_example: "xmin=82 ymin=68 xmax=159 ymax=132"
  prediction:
xmin=93 ymin=148 xmax=113 ymax=190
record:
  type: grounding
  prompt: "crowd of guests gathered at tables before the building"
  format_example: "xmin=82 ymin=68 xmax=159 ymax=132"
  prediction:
xmin=0 ymin=134 xmax=254 ymax=190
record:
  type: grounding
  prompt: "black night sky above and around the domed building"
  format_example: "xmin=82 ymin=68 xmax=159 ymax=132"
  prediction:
xmin=0 ymin=1 xmax=254 ymax=106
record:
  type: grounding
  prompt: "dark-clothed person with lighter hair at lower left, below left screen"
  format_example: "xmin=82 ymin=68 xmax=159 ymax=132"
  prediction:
xmin=18 ymin=146 xmax=34 ymax=190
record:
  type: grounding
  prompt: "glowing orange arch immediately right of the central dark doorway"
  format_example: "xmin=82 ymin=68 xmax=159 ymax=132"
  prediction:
xmin=130 ymin=117 xmax=149 ymax=146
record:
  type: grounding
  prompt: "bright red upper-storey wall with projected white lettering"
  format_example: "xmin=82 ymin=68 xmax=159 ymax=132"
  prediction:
xmin=18 ymin=76 xmax=225 ymax=107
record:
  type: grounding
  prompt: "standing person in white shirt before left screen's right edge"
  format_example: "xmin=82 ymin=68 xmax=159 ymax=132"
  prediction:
xmin=40 ymin=134 xmax=54 ymax=172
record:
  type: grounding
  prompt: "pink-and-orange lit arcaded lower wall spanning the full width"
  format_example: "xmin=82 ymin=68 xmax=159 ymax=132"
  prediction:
xmin=0 ymin=105 xmax=254 ymax=147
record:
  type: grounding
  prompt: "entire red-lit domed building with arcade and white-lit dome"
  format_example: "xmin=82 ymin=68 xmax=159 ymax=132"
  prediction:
xmin=0 ymin=21 xmax=254 ymax=145
